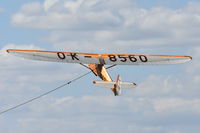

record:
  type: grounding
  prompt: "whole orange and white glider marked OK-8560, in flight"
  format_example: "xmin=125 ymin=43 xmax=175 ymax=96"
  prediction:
xmin=7 ymin=49 xmax=192 ymax=96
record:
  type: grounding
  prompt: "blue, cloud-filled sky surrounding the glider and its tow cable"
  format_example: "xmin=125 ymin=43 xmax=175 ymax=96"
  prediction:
xmin=0 ymin=0 xmax=200 ymax=133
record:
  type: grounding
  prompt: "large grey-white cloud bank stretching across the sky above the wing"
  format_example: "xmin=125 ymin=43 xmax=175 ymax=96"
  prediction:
xmin=11 ymin=0 xmax=200 ymax=52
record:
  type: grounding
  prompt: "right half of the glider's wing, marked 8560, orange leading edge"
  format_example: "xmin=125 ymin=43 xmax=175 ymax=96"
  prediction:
xmin=102 ymin=54 xmax=192 ymax=65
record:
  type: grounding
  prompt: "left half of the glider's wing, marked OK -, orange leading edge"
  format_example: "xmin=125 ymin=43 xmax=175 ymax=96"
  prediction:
xmin=7 ymin=49 xmax=99 ymax=64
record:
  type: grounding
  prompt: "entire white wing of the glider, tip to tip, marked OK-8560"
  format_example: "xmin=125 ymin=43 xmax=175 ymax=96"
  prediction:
xmin=7 ymin=49 xmax=192 ymax=65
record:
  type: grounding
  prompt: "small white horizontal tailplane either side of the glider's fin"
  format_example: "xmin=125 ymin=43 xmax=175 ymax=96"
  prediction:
xmin=93 ymin=81 xmax=137 ymax=89
